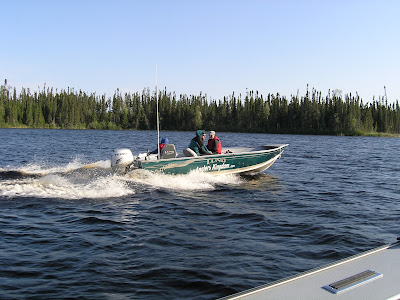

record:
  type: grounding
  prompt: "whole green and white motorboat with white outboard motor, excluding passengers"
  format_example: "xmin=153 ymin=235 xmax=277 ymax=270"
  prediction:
xmin=111 ymin=144 xmax=288 ymax=175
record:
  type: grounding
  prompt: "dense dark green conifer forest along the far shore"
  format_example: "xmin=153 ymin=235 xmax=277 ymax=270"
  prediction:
xmin=0 ymin=80 xmax=400 ymax=135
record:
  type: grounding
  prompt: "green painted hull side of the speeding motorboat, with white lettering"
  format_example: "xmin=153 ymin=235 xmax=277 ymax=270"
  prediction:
xmin=138 ymin=144 xmax=287 ymax=175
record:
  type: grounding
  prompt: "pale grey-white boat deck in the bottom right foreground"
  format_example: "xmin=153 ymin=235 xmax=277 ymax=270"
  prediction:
xmin=222 ymin=243 xmax=400 ymax=300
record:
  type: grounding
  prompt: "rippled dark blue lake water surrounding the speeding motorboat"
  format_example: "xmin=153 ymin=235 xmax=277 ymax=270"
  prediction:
xmin=0 ymin=129 xmax=400 ymax=299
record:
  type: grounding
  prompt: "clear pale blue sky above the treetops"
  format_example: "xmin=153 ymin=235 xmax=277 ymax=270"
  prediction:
xmin=0 ymin=0 xmax=400 ymax=102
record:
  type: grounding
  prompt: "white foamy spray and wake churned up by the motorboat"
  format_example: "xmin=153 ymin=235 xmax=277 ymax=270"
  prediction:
xmin=0 ymin=158 xmax=242 ymax=200
